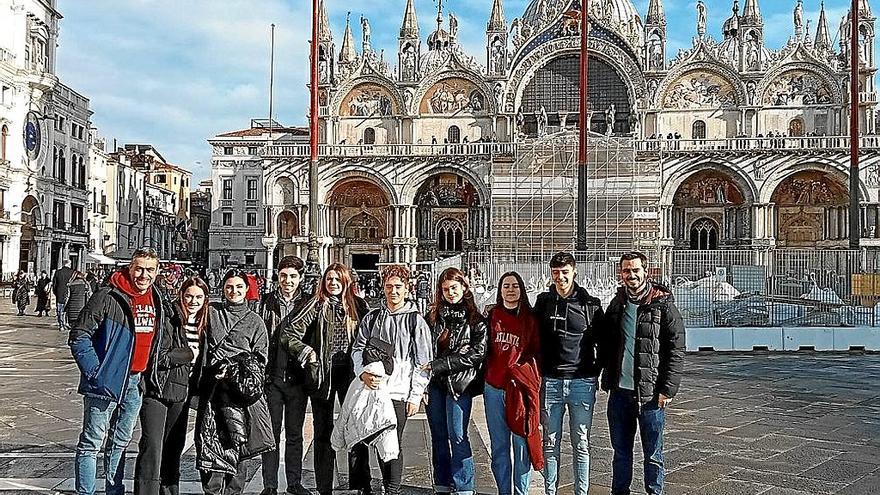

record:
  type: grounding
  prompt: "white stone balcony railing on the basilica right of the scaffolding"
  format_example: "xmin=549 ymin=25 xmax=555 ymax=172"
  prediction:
xmin=635 ymin=136 xmax=880 ymax=153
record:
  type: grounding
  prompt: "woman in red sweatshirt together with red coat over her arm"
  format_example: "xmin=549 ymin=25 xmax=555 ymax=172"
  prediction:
xmin=483 ymin=272 xmax=544 ymax=495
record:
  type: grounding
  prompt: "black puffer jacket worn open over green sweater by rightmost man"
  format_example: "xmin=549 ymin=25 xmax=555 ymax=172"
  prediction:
xmin=601 ymin=282 xmax=685 ymax=404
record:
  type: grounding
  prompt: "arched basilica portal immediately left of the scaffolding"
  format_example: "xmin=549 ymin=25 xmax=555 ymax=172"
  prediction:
xmin=415 ymin=173 xmax=483 ymax=260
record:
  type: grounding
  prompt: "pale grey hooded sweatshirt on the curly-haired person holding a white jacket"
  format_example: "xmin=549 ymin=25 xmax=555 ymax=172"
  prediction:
xmin=351 ymin=302 xmax=434 ymax=404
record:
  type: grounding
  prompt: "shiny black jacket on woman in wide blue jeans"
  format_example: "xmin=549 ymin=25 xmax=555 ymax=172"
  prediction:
xmin=431 ymin=304 xmax=489 ymax=399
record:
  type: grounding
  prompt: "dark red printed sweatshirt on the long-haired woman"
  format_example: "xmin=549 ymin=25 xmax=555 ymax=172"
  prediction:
xmin=486 ymin=306 xmax=540 ymax=389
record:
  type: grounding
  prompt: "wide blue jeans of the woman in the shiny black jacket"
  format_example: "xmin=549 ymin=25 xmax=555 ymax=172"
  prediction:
xmin=426 ymin=383 xmax=474 ymax=495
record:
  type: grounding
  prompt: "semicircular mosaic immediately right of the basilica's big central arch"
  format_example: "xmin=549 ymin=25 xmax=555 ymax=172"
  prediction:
xmin=663 ymin=70 xmax=737 ymax=110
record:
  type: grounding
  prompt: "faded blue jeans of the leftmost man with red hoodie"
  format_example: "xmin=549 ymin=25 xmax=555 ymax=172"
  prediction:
xmin=74 ymin=373 xmax=141 ymax=495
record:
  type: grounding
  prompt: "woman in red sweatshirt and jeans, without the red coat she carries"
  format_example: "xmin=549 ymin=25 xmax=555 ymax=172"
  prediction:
xmin=483 ymin=272 xmax=539 ymax=495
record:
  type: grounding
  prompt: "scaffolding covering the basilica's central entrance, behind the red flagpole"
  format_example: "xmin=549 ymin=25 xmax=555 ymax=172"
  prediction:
xmin=491 ymin=128 xmax=660 ymax=259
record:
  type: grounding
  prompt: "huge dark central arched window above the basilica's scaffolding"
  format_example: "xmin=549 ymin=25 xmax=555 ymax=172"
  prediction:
xmin=520 ymin=54 xmax=633 ymax=136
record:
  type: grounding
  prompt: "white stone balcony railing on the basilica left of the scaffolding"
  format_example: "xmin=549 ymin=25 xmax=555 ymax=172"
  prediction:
xmin=263 ymin=143 xmax=516 ymax=158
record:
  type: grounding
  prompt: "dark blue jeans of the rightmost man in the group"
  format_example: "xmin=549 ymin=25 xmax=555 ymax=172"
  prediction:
xmin=608 ymin=389 xmax=666 ymax=495
